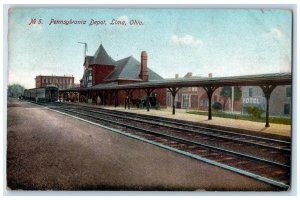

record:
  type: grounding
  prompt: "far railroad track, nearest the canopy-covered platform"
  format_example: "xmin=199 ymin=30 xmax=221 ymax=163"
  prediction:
xmin=52 ymin=104 xmax=291 ymax=156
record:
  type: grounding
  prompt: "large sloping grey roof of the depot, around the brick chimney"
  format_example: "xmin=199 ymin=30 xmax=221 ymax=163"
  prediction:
xmin=106 ymin=56 xmax=163 ymax=81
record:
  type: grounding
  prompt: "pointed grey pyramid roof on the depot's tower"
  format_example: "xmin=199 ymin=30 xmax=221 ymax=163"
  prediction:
xmin=87 ymin=44 xmax=115 ymax=65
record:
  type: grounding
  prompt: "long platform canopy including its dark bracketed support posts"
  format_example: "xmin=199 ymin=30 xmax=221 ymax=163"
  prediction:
xmin=59 ymin=73 xmax=292 ymax=127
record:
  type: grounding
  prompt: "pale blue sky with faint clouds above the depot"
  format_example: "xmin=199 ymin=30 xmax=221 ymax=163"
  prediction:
xmin=7 ymin=8 xmax=292 ymax=88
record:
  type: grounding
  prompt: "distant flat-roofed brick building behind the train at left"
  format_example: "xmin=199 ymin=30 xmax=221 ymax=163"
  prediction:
xmin=35 ymin=75 xmax=74 ymax=89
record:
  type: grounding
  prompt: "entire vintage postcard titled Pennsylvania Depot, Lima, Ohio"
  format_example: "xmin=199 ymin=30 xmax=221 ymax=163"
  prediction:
xmin=6 ymin=7 xmax=296 ymax=192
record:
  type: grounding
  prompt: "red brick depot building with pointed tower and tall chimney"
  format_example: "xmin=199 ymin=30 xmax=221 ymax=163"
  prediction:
xmin=79 ymin=44 xmax=167 ymax=107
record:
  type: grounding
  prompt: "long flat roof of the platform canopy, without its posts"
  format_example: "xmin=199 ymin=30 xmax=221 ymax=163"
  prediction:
xmin=60 ymin=73 xmax=292 ymax=92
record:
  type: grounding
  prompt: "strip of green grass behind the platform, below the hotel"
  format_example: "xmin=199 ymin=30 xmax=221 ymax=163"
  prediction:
xmin=187 ymin=111 xmax=292 ymax=125
